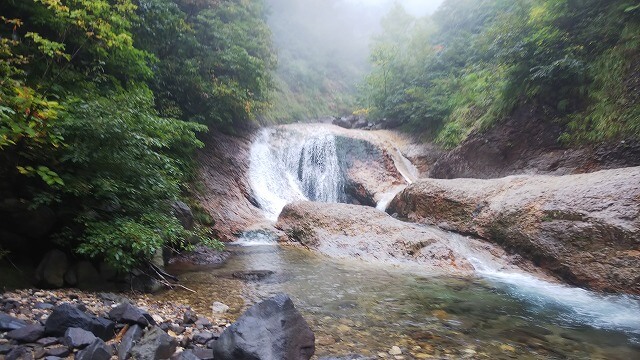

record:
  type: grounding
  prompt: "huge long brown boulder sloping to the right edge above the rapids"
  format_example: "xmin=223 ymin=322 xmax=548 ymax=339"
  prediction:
xmin=388 ymin=167 xmax=640 ymax=294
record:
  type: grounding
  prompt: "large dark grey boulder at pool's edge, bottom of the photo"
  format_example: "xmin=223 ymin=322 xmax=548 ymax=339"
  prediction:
xmin=213 ymin=294 xmax=315 ymax=360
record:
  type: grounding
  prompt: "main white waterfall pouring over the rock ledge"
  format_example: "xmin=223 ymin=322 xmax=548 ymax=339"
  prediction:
xmin=249 ymin=129 xmax=344 ymax=221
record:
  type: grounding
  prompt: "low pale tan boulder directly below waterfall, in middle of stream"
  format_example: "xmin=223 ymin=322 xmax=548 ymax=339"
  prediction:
xmin=276 ymin=202 xmax=524 ymax=275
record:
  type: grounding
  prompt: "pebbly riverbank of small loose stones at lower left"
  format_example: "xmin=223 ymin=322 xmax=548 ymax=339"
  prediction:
xmin=0 ymin=289 xmax=231 ymax=360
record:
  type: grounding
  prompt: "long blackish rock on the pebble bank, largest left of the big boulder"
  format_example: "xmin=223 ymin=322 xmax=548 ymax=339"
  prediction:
xmin=45 ymin=304 xmax=115 ymax=340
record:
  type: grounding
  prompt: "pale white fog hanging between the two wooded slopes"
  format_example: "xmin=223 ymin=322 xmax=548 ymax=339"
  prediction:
xmin=266 ymin=0 xmax=444 ymax=120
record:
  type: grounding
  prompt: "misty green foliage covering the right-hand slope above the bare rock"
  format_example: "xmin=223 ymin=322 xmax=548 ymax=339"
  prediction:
xmin=362 ymin=0 xmax=640 ymax=147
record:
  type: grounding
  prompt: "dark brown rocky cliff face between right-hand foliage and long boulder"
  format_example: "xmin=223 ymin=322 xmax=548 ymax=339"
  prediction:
xmin=430 ymin=108 xmax=640 ymax=179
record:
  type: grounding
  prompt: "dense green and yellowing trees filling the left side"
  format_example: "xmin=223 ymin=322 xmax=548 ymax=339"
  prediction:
xmin=0 ymin=0 xmax=275 ymax=269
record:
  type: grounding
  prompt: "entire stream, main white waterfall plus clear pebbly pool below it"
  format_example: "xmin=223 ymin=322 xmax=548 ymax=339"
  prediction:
xmin=157 ymin=126 xmax=640 ymax=359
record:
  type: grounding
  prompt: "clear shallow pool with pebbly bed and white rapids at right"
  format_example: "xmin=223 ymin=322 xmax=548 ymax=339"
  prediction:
xmin=158 ymin=245 xmax=640 ymax=360
